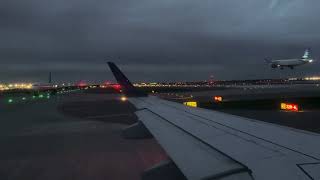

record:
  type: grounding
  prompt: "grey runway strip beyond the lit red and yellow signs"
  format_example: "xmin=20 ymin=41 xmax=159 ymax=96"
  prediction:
xmin=157 ymin=84 xmax=320 ymax=102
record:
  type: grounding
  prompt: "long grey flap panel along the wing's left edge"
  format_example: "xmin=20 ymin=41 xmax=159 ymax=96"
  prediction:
xmin=136 ymin=109 xmax=251 ymax=179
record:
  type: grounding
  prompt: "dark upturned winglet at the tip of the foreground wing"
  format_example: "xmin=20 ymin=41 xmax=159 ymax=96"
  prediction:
xmin=108 ymin=62 xmax=147 ymax=97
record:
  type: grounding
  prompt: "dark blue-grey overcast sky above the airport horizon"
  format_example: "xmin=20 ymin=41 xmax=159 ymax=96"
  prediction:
xmin=0 ymin=0 xmax=320 ymax=81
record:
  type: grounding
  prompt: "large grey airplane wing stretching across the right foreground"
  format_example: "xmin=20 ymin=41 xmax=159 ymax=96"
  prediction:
xmin=109 ymin=63 xmax=320 ymax=180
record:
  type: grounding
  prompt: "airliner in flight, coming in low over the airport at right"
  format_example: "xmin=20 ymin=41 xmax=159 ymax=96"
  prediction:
xmin=266 ymin=49 xmax=313 ymax=69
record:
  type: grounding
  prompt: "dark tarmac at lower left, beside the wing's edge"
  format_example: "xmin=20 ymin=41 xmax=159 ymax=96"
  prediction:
xmin=0 ymin=94 xmax=167 ymax=180
